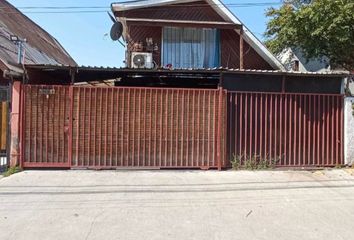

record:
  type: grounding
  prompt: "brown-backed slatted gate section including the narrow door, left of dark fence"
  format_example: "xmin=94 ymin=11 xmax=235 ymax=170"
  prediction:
xmin=22 ymin=85 xmax=226 ymax=169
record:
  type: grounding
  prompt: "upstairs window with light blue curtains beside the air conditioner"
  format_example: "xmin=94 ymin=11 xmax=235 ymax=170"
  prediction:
xmin=162 ymin=27 xmax=220 ymax=68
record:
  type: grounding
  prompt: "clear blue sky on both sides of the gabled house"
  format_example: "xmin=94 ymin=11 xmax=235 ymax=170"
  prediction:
xmin=8 ymin=0 xmax=280 ymax=67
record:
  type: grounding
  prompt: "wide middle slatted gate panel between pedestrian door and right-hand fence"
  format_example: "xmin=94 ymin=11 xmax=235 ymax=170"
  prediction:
xmin=66 ymin=87 xmax=225 ymax=169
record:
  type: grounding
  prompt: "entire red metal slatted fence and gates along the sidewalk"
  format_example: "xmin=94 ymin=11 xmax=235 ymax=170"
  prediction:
xmin=21 ymin=85 xmax=343 ymax=169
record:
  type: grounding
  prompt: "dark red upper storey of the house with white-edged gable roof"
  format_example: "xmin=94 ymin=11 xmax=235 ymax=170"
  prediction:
xmin=112 ymin=0 xmax=284 ymax=70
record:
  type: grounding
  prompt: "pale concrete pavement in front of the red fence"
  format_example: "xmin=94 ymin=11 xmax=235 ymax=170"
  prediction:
xmin=0 ymin=170 xmax=354 ymax=240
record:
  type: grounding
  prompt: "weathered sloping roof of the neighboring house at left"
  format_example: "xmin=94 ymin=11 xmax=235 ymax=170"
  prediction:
xmin=0 ymin=1 xmax=77 ymax=71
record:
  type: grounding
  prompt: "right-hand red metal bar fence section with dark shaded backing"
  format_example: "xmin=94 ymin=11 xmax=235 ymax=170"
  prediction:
xmin=227 ymin=92 xmax=343 ymax=167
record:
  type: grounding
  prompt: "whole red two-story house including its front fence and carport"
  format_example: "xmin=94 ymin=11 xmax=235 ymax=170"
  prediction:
xmin=7 ymin=0 xmax=346 ymax=169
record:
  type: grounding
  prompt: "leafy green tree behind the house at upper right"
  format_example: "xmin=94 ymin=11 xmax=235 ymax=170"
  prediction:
xmin=265 ymin=0 xmax=354 ymax=70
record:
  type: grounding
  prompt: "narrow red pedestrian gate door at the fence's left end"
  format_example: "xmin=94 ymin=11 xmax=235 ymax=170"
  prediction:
xmin=22 ymin=85 xmax=71 ymax=168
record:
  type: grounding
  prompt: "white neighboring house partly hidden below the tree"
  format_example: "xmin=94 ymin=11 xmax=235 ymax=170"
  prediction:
xmin=277 ymin=48 xmax=332 ymax=72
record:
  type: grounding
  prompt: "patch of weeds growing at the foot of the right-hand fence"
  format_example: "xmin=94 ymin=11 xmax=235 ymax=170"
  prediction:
xmin=231 ymin=155 xmax=280 ymax=170
